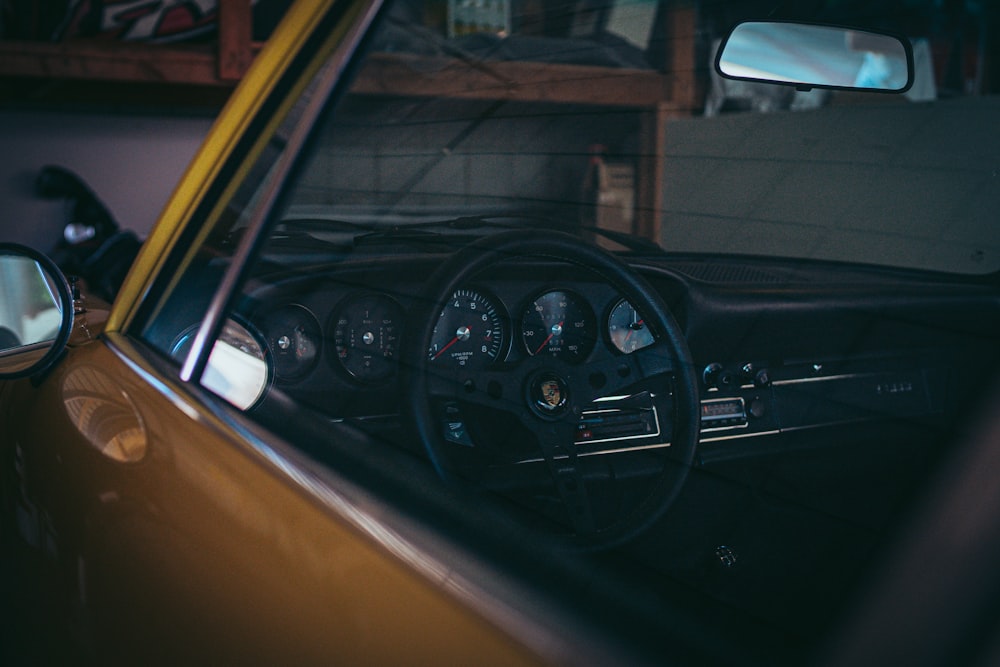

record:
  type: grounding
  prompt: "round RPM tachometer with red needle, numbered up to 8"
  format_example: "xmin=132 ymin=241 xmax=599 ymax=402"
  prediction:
xmin=427 ymin=289 xmax=504 ymax=368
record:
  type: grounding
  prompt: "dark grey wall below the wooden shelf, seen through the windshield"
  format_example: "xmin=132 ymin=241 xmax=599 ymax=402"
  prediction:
xmin=295 ymin=98 xmax=639 ymax=221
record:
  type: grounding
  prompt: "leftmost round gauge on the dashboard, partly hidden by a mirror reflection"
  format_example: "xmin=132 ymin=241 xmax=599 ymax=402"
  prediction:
xmin=258 ymin=304 xmax=322 ymax=380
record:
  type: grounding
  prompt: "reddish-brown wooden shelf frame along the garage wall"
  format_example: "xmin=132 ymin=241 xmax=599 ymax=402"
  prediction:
xmin=0 ymin=0 xmax=700 ymax=239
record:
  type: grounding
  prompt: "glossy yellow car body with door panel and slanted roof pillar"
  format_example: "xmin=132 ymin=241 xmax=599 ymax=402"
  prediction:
xmin=0 ymin=1 xmax=552 ymax=665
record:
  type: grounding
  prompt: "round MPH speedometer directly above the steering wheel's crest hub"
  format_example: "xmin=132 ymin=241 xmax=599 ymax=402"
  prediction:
xmin=521 ymin=291 xmax=597 ymax=362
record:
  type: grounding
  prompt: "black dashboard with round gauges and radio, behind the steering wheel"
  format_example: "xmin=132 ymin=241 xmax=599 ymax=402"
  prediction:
xmin=166 ymin=250 xmax=1000 ymax=464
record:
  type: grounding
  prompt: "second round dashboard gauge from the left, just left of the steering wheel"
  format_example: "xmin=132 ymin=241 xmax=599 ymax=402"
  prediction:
xmin=333 ymin=294 xmax=403 ymax=382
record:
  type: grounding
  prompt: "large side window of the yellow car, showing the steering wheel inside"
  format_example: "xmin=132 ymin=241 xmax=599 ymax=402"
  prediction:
xmin=133 ymin=1 xmax=1000 ymax=664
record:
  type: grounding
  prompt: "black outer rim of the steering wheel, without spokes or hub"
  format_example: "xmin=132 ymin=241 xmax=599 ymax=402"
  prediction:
xmin=402 ymin=230 xmax=700 ymax=547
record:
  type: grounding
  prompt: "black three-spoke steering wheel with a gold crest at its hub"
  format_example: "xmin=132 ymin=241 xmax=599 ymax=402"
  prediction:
xmin=402 ymin=230 xmax=700 ymax=547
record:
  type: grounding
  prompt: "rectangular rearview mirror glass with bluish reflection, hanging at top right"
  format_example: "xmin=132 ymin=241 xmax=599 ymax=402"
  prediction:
xmin=717 ymin=22 xmax=912 ymax=92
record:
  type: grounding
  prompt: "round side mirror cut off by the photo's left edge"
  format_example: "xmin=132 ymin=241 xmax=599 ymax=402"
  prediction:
xmin=0 ymin=243 xmax=73 ymax=380
